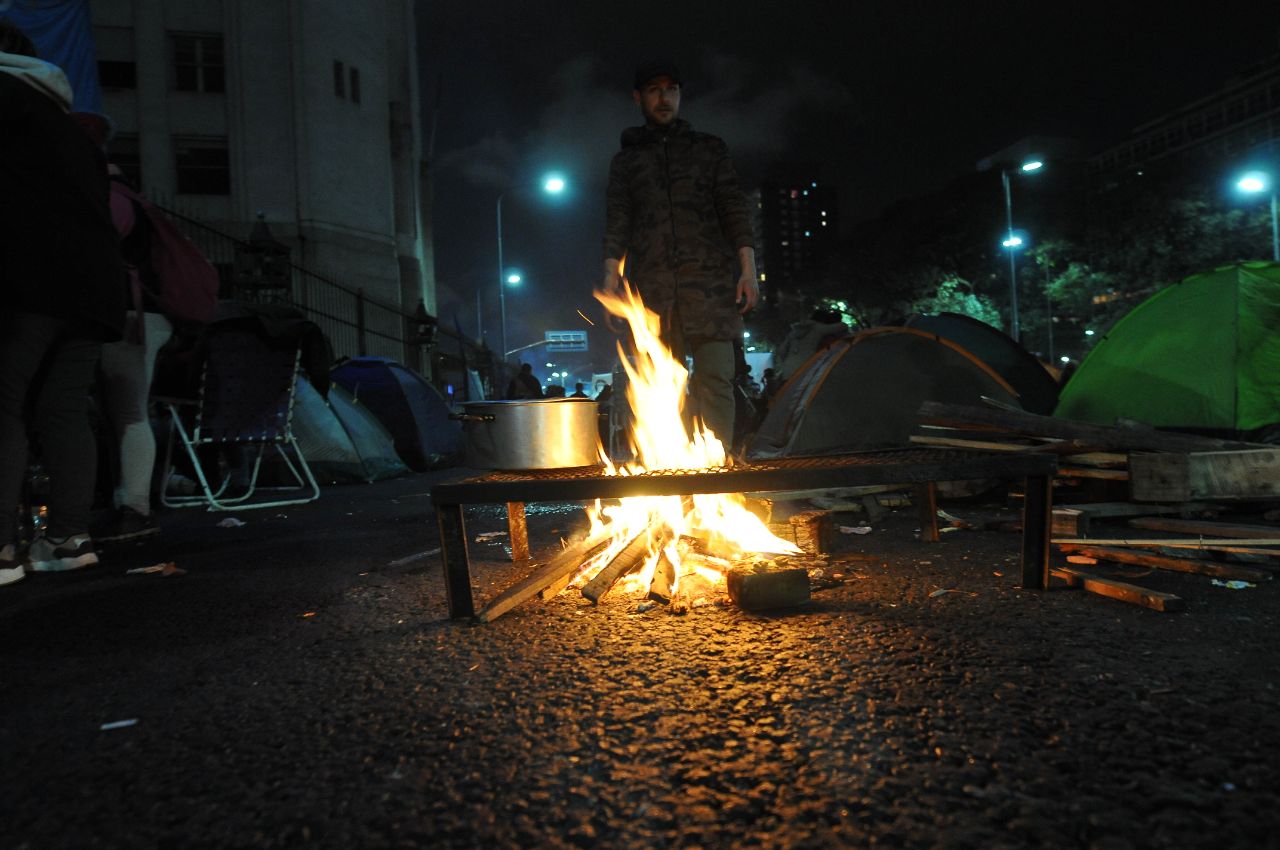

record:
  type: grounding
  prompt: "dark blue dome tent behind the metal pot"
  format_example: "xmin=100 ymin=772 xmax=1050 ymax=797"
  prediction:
xmin=329 ymin=357 xmax=462 ymax=472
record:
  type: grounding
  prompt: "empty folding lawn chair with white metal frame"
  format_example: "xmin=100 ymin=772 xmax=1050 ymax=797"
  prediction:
xmin=156 ymin=325 xmax=320 ymax=511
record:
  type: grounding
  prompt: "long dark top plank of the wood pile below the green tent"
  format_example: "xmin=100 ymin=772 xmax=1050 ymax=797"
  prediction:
xmin=919 ymin=401 xmax=1268 ymax=455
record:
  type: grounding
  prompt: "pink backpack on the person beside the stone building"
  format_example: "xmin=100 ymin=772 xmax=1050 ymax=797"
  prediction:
xmin=113 ymin=180 xmax=219 ymax=324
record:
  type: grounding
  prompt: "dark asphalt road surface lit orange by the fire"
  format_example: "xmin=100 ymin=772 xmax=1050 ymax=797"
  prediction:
xmin=0 ymin=470 xmax=1280 ymax=850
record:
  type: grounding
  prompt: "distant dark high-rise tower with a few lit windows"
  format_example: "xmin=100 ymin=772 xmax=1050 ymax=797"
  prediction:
xmin=756 ymin=170 xmax=840 ymax=292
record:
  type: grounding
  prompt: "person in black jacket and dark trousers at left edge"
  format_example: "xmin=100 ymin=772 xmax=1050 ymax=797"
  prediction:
xmin=0 ymin=20 xmax=127 ymax=584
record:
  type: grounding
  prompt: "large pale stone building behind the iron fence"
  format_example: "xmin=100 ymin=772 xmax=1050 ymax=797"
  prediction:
xmin=92 ymin=0 xmax=435 ymax=355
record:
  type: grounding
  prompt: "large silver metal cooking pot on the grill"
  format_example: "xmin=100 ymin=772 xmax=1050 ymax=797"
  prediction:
xmin=452 ymin=398 xmax=600 ymax=470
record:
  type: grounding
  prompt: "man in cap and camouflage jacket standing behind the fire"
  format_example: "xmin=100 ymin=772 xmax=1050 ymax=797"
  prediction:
xmin=604 ymin=61 xmax=760 ymax=451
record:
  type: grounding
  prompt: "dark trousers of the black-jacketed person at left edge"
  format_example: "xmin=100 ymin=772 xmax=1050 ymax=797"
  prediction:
xmin=0 ymin=312 xmax=102 ymax=547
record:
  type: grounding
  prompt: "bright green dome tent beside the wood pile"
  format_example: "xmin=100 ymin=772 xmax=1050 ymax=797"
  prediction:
xmin=1053 ymin=262 xmax=1280 ymax=431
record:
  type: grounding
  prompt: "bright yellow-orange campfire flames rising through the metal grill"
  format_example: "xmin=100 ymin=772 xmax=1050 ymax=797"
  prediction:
xmin=573 ymin=268 xmax=800 ymax=601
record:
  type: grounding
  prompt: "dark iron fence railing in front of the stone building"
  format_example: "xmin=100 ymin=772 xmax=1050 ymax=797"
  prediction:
xmin=157 ymin=205 xmax=503 ymax=401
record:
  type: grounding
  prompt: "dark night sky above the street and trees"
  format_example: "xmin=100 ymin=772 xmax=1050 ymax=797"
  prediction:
xmin=419 ymin=0 xmax=1280 ymax=371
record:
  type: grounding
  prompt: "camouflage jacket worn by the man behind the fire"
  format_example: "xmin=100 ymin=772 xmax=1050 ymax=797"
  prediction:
xmin=604 ymin=120 xmax=754 ymax=339
